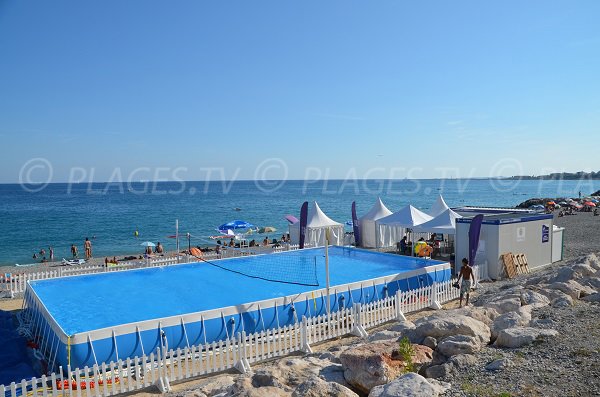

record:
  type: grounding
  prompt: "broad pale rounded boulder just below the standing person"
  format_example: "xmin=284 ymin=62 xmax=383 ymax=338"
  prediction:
xmin=414 ymin=310 xmax=491 ymax=344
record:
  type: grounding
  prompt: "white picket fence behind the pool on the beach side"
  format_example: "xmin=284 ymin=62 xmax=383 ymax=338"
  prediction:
xmin=0 ymin=244 xmax=299 ymax=296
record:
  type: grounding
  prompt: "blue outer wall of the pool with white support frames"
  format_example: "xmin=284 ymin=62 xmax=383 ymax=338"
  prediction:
xmin=25 ymin=255 xmax=451 ymax=368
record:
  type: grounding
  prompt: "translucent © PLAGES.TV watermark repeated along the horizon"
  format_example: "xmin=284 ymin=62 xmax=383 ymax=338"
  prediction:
xmin=19 ymin=157 xmax=593 ymax=196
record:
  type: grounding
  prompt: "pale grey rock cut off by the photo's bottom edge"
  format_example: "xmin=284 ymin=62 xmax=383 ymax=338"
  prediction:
xmin=369 ymin=373 xmax=450 ymax=397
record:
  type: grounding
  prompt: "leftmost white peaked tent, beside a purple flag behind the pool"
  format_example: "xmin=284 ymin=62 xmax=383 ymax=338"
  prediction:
xmin=290 ymin=201 xmax=344 ymax=247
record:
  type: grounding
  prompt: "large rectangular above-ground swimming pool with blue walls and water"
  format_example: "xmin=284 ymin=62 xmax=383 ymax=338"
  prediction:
xmin=25 ymin=247 xmax=451 ymax=368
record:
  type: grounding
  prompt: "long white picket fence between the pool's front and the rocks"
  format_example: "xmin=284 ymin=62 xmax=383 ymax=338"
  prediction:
xmin=0 ymin=268 xmax=479 ymax=397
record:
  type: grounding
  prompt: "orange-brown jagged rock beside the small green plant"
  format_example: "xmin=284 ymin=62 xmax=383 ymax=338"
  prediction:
xmin=340 ymin=342 xmax=433 ymax=393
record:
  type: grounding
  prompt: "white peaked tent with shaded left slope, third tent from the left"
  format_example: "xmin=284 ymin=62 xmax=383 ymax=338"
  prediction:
xmin=375 ymin=205 xmax=433 ymax=247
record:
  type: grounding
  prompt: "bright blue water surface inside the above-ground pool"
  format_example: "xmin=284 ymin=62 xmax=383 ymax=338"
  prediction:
xmin=31 ymin=247 xmax=442 ymax=335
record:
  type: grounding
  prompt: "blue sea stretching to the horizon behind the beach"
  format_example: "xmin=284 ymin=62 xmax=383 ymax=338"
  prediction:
xmin=0 ymin=179 xmax=600 ymax=266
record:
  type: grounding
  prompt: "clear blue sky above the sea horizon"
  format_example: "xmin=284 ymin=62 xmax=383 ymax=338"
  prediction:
xmin=0 ymin=0 xmax=600 ymax=182
